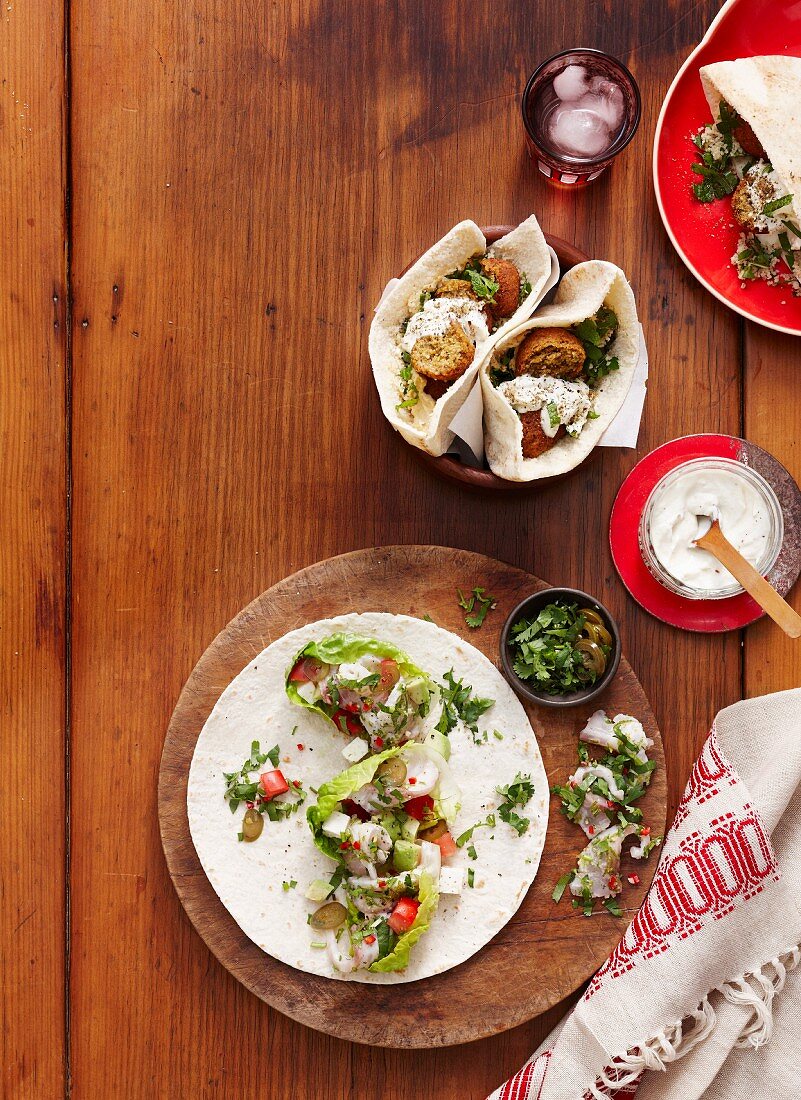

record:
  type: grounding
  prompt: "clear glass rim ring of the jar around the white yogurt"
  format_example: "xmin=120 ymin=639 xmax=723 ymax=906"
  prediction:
xmin=638 ymin=454 xmax=784 ymax=600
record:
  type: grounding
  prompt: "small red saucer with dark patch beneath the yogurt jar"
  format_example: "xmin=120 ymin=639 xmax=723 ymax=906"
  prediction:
xmin=610 ymin=435 xmax=801 ymax=634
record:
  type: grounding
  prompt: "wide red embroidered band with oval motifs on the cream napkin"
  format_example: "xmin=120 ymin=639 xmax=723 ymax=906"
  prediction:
xmin=585 ymin=806 xmax=779 ymax=998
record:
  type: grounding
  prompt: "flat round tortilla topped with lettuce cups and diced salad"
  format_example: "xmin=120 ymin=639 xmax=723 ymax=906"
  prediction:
xmin=187 ymin=616 xmax=549 ymax=983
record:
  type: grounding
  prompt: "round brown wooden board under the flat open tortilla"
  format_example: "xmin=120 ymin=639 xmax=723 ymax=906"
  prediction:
xmin=158 ymin=546 xmax=667 ymax=1047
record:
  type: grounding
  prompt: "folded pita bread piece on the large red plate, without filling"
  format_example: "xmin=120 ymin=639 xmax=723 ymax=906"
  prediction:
xmin=701 ymin=55 xmax=801 ymax=217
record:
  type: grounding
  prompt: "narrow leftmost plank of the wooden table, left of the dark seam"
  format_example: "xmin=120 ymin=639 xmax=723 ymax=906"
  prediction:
xmin=0 ymin=0 xmax=67 ymax=1100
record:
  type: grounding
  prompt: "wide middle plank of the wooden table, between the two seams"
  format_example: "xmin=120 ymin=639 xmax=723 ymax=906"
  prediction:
xmin=62 ymin=0 xmax=752 ymax=1100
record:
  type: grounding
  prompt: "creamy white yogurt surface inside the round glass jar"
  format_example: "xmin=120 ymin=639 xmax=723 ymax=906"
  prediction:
xmin=649 ymin=470 xmax=771 ymax=591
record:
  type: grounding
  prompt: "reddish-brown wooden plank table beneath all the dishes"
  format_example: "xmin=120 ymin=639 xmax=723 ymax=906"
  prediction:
xmin=6 ymin=0 xmax=801 ymax=1100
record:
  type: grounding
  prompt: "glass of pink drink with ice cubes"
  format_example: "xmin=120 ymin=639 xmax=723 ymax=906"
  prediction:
xmin=522 ymin=50 xmax=640 ymax=185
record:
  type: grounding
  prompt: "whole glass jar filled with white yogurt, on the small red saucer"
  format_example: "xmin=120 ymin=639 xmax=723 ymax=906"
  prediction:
xmin=647 ymin=459 xmax=781 ymax=594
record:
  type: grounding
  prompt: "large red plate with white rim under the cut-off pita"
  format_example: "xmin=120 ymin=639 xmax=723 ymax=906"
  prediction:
xmin=654 ymin=0 xmax=801 ymax=336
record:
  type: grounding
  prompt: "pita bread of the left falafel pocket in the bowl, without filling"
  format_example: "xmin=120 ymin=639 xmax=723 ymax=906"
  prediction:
xmin=369 ymin=215 xmax=550 ymax=454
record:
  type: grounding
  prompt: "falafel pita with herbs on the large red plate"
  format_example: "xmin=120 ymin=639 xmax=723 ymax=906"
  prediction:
xmin=692 ymin=56 xmax=801 ymax=297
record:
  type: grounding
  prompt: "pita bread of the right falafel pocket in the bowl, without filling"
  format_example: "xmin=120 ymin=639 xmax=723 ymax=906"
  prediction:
xmin=479 ymin=260 xmax=639 ymax=482
